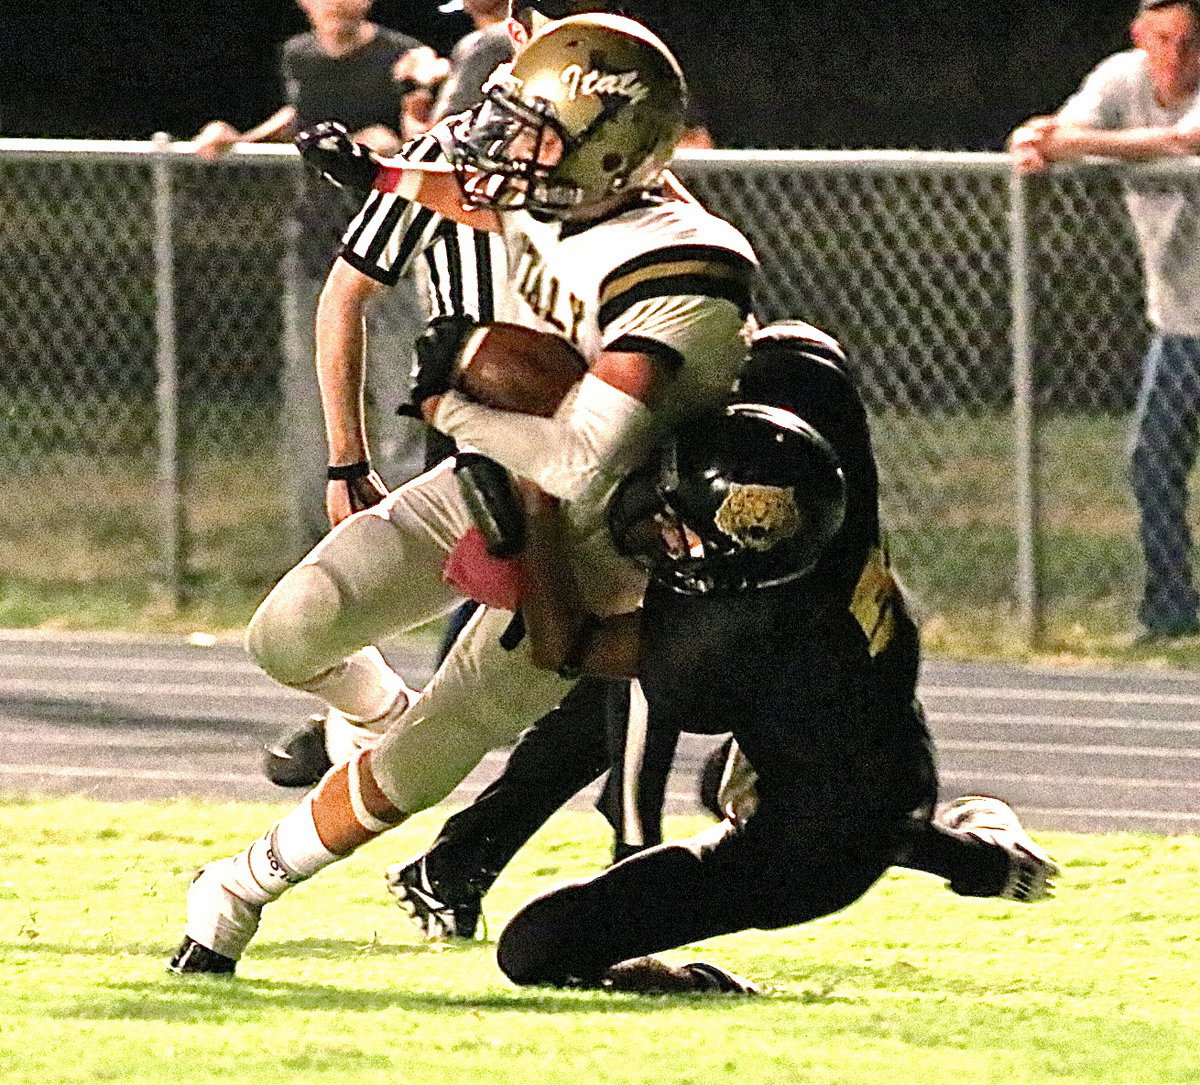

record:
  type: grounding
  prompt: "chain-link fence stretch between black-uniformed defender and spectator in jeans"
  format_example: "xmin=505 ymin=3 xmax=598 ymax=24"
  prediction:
xmin=682 ymin=151 xmax=1161 ymax=646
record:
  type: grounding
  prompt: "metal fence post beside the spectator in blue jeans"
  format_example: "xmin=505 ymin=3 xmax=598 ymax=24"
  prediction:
xmin=1008 ymin=158 xmax=1043 ymax=648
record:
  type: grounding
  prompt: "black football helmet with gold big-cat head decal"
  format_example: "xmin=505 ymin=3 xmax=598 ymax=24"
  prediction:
xmin=608 ymin=403 xmax=846 ymax=595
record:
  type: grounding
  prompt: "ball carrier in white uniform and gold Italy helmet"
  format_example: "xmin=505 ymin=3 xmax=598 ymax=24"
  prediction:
xmin=172 ymin=16 xmax=755 ymax=972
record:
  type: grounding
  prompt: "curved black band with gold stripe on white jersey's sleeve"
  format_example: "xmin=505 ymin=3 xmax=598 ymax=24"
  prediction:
xmin=600 ymin=245 xmax=755 ymax=329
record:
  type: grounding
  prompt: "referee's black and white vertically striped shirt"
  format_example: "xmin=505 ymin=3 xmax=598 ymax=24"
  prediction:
xmin=341 ymin=124 xmax=509 ymax=323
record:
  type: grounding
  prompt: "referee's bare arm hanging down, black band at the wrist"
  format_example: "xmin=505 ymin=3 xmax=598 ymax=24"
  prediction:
xmin=317 ymin=259 xmax=386 ymax=526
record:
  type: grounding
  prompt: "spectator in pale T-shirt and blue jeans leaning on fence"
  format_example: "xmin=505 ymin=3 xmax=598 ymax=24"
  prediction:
xmin=1010 ymin=0 xmax=1200 ymax=641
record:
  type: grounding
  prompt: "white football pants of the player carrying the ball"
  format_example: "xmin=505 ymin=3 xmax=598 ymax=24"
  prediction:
xmin=246 ymin=461 xmax=643 ymax=814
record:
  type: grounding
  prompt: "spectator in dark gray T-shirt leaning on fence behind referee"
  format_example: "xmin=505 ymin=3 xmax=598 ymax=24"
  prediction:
xmin=196 ymin=0 xmax=446 ymax=553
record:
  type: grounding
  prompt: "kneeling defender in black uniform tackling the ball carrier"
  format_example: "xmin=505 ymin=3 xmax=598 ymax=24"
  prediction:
xmin=498 ymin=325 xmax=1055 ymax=990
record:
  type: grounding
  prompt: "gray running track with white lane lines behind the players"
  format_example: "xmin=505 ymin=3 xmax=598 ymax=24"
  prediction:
xmin=0 ymin=631 xmax=1200 ymax=833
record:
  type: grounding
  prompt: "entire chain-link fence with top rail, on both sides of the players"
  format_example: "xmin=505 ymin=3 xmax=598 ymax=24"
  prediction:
xmin=0 ymin=140 xmax=1180 ymax=640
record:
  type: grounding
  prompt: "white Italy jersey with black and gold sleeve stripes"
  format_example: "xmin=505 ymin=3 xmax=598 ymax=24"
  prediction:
xmin=497 ymin=197 xmax=757 ymax=613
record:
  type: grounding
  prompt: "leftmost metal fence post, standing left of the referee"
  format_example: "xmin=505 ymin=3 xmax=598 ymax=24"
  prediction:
xmin=152 ymin=132 xmax=186 ymax=609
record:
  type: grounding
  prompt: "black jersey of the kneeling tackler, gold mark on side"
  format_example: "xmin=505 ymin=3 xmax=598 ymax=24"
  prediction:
xmin=638 ymin=352 xmax=924 ymax=811
